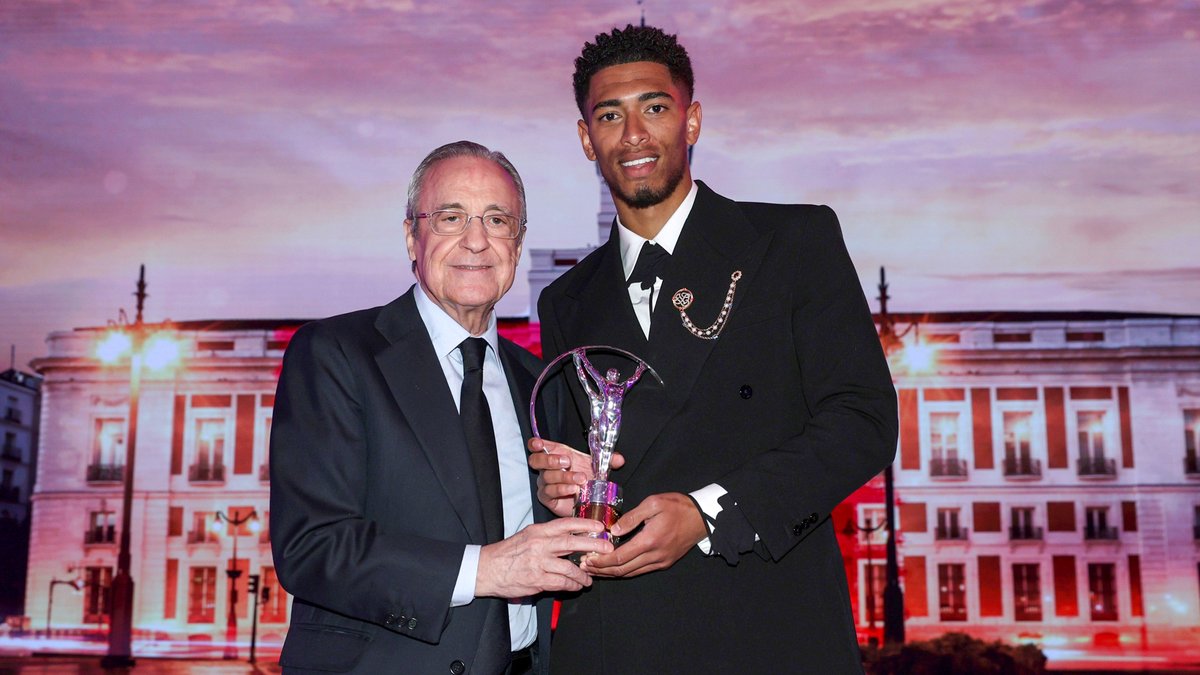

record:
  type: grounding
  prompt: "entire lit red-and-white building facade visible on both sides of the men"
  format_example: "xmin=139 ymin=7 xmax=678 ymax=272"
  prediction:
xmin=18 ymin=306 xmax=1200 ymax=655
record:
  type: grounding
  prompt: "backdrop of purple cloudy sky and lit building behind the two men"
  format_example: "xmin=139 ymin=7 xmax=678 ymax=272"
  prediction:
xmin=0 ymin=0 xmax=1200 ymax=668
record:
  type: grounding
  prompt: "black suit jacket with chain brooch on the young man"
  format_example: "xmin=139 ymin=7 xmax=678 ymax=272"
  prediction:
xmin=538 ymin=184 xmax=898 ymax=675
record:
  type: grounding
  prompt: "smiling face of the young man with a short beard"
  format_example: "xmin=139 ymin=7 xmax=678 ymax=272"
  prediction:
xmin=578 ymin=61 xmax=701 ymax=209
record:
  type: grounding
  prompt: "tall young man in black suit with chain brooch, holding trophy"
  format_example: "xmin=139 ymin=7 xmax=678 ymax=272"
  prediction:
xmin=529 ymin=26 xmax=898 ymax=675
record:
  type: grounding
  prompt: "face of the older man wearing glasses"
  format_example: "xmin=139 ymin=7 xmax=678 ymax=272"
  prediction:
xmin=404 ymin=157 xmax=523 ymax=335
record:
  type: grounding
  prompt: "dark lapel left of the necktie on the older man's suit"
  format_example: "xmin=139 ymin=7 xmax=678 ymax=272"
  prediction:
xmin=376 ymin=289 xmax=487 ymax=543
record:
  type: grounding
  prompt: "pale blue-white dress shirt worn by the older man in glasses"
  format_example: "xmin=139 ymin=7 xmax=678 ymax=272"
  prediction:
xmin=414 ymin=283 xmax=538 ymax=651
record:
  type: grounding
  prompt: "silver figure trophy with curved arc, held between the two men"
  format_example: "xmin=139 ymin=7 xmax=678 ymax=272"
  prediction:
xmin=529 ymin=345 xmax=662 ymax=539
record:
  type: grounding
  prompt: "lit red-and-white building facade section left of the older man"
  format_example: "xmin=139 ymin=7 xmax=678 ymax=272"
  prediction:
xmin=25 ymin=321 xmax=301 ymax=646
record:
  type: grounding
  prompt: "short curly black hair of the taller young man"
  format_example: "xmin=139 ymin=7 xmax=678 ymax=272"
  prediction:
xmin=575 ymin=24 xmax=695 ymax=119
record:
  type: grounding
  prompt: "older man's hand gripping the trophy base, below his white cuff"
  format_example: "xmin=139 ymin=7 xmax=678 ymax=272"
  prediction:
xmin=475 ymin=518 xmax=612 ymax=598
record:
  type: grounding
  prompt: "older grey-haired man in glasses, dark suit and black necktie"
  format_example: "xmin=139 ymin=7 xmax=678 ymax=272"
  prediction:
xmin=270 ymin=142 xmax=611 ymax=674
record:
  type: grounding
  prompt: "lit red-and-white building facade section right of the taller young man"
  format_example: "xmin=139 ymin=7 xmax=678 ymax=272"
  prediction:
xmin=834 ymin=312 xmax=1200 ymax=653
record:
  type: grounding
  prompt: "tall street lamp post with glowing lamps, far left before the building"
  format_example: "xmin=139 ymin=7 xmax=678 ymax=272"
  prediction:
xmin=97 ymin=265 xmax=178 ymax=668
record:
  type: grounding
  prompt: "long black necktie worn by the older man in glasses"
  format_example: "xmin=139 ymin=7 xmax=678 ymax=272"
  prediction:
xmin=458 ymin=338 xmax=504 ymax=544
